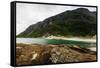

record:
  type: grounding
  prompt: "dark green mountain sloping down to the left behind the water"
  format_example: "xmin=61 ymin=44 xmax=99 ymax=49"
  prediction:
xmin=17 ymin=8 xmax=97 ymax=37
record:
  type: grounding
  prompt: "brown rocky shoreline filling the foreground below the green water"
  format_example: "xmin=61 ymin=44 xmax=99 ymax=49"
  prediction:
xmin=16 ymin=43 xmax=96 ymax=65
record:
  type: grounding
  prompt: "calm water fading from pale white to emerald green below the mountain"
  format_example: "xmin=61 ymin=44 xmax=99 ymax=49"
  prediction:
xmin=16 ymin=38 xmax=96 ymax=47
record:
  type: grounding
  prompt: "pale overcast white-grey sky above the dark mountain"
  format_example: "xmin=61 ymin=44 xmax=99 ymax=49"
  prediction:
xmin=16 ymin=3 xmax=96 ymax=35
